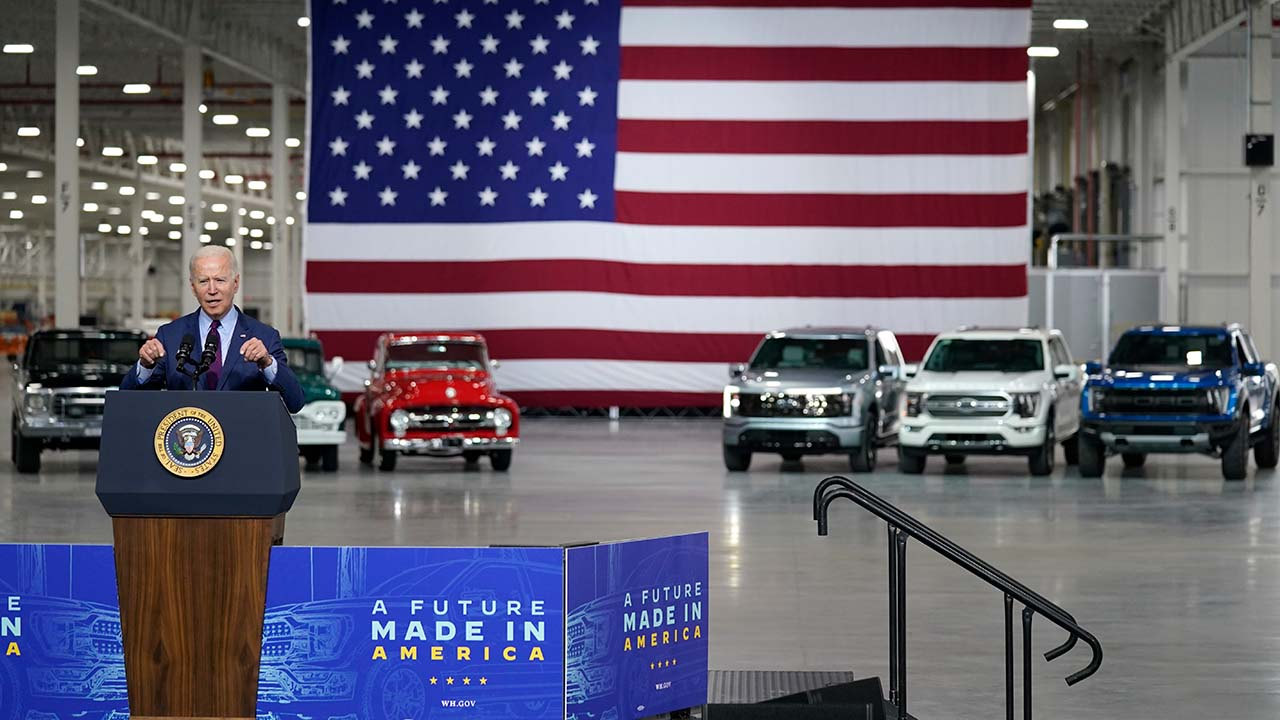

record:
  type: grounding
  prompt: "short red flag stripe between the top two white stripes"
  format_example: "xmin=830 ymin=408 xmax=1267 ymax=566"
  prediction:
xmin=622 ymin=46 xmax=1028 ymax=82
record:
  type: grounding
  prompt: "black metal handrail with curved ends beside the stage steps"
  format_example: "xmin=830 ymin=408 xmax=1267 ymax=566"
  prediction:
xmin=813 ymin=475 xmax=1102 ymax=720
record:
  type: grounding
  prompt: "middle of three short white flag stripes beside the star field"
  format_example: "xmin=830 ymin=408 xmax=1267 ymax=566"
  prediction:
xmin=618 ymin=79 xmax=1027 ymax=120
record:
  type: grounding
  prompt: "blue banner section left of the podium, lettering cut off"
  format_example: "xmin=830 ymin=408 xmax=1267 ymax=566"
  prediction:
xmin=0 ymin=544 xmax=129 ymax=720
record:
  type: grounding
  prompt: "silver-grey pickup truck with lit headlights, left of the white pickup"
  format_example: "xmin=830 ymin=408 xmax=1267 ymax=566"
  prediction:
xmin=723 ymin=328 xmax=902 ymax=473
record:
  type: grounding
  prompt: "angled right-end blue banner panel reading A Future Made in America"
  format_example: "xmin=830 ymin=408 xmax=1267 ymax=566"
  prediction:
xmin=564 ymin=533 xmax=709 ymax=720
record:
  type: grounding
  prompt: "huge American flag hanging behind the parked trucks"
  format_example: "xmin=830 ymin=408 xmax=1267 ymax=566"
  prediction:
xmin=305 ymin=0 xmax=1030 ymax=406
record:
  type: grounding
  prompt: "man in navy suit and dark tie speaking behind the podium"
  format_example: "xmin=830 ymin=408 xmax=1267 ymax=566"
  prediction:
xmin=120 ymin=245 xmax=305 ymax=413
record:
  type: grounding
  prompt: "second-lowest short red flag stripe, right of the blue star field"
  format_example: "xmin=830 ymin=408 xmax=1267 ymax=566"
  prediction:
xmin=618 ymin=119 xmax=1027 ymax=155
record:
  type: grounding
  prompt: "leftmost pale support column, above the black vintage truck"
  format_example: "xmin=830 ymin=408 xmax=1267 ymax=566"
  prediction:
xmin=54 ymin=0 xmax=81 ymax=328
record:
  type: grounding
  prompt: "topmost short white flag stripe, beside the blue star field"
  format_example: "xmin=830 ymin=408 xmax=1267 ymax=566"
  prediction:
xmin=621 ymin=8 xmax=1032 ymax=47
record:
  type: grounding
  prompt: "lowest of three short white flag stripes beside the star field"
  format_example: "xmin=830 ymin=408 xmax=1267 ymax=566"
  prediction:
xmin=614 ymin=152 xmax=1029 ymax=195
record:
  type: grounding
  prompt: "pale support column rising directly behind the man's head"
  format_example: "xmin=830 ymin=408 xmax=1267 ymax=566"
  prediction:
xmin=178 ymin=3 xmax=205 ymax=313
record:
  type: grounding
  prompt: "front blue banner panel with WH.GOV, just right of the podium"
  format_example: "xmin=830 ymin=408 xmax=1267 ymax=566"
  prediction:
xmin=257 ymin=547 xmax=564 ymax=720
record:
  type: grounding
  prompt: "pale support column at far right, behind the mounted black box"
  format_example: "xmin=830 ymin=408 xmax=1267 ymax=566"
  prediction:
xmin=1248 ymin=0 xmax=1275 ymax=357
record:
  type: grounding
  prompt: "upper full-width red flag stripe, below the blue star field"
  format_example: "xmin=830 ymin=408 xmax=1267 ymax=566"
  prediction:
xmin=307 ymin=260 xmax=1027 ymax=297
